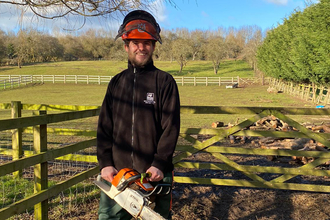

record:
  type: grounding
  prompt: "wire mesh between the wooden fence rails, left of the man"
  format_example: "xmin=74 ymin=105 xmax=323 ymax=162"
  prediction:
xmin=0 ymin=112 xmax=99 ymax=219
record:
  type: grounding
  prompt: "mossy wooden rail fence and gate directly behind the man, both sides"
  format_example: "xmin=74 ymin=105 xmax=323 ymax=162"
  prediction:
xmin=0 ymin=102 xmax=330 ymax=219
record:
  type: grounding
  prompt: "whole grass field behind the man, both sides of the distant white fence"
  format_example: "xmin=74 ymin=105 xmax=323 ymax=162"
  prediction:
xmin=0 ymin=60 xmax=318 ymax=128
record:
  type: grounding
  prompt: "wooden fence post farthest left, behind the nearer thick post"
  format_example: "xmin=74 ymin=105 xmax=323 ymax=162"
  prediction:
xmin=11 ymin=101 xmax=23 ymax=178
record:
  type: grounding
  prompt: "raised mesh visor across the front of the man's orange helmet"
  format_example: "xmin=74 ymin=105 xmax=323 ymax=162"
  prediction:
xmin=115 ymin=20 xmax=162 ymax=44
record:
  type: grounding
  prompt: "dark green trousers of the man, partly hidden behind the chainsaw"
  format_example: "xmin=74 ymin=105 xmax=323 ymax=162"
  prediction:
xmin=98 ymin=172 xmax=173 ymax=220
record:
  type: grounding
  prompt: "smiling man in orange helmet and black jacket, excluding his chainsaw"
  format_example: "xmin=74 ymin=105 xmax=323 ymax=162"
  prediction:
xmin=97 ymin=10 xmax=180 ymax=220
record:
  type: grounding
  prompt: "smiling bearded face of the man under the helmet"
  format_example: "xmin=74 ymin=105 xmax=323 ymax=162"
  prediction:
xmin=125 ymin=40 xmax=155 ymax=67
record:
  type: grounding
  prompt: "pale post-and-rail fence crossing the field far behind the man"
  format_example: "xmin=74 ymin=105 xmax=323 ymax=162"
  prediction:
xmin=0 ymin=75 xmax=330 ymax=105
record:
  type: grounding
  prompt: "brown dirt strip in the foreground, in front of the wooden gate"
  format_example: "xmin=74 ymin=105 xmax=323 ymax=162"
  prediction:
xmin=173 ymin=185 xmax=330 ymax=220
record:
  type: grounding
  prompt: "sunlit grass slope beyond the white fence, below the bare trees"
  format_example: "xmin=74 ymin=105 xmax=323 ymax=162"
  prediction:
xmin=0 ymin=60 xmax=253 ymax=77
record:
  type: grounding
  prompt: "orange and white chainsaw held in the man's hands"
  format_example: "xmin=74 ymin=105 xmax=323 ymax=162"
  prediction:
xmin=94 ymin=168 xmax=171 ymax=220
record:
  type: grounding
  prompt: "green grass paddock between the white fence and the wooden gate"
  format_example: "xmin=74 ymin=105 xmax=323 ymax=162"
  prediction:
xmin=0 ymin=84 xmax=313 ymax=129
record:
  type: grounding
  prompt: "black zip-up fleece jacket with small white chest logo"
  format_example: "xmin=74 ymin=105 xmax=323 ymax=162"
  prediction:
xmin=97 ymin=59 xmax=180 ymax=172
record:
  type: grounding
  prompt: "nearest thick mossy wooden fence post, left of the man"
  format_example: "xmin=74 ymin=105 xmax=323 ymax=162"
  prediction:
xmin=33 ymin=111 xmax=48 ymax=220
